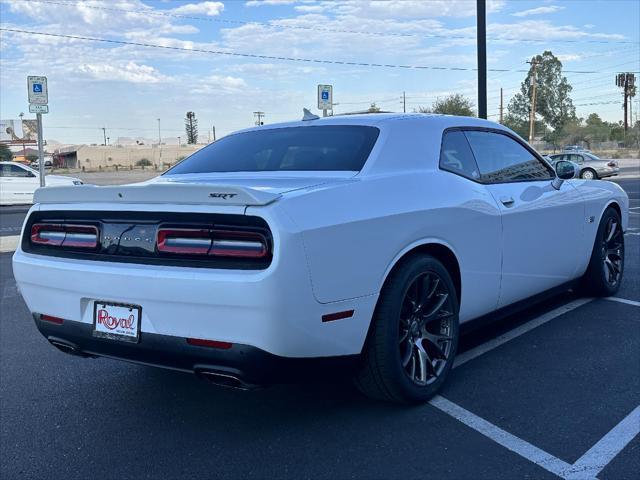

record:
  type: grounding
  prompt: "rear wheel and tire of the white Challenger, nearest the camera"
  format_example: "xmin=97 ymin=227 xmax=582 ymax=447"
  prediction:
xmin=355 ymin=255 xmax=459 ymax=403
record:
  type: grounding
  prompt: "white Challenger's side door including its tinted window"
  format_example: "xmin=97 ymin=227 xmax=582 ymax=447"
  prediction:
xmin=465 ymin=129 xmax=584 ymax=307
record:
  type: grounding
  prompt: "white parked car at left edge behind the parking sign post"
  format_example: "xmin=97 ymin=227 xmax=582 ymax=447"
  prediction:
xmin=0 ymin=162 xmax=82 ymax=205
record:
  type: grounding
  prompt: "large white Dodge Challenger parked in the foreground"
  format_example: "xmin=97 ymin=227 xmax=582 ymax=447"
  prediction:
xmin=13 ymin=114 xmax=628 ymax=403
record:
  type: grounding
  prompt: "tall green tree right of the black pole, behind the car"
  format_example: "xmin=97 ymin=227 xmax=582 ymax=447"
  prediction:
xmin=507 ymin=50 xmax=576 ymax=134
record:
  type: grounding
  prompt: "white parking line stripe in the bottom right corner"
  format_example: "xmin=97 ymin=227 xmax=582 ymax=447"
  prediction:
xmin=554 ymin=406 xmax=640 ymax=480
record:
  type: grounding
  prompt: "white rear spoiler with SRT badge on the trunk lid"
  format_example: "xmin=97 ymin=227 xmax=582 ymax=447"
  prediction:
xmin=34 ymin=183 xmax=281 ymax=206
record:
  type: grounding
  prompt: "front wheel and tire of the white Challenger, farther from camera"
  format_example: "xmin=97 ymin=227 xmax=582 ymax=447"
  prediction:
xmin=582 ymin=207 xmax=624 ymax=297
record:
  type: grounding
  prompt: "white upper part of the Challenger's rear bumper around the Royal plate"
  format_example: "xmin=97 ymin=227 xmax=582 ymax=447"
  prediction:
xmin=13 ymin=246 xmax=377 ymax=358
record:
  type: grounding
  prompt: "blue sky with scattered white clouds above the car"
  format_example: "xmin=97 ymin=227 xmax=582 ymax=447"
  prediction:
xmin=0 ymin=0 xmax=640 ymax=143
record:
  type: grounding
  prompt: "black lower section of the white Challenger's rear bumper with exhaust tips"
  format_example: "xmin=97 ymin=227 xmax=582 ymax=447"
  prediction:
xmin=33 ymin=314 xmax=357 ymax=388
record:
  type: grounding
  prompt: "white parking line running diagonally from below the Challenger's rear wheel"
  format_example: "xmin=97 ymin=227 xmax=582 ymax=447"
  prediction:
xmin=429 ymin=395 xmax=572 ymax=476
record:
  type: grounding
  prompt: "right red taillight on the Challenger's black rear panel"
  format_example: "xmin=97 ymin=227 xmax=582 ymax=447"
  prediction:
xmin=156 ymin=227 xmax=269 ymax=258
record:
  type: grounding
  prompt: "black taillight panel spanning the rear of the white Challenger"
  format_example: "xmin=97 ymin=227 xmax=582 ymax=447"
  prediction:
xmin=22 ymin=211 xmax=273 ymax=269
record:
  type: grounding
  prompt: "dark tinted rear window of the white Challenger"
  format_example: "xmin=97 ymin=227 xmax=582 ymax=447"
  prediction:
xmin=167 ymin=125 xmax=379 ymax=175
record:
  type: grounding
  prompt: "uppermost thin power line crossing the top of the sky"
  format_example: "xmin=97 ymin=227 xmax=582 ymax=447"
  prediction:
xmin=17 ymin=0 xmax=639 ymax=44
